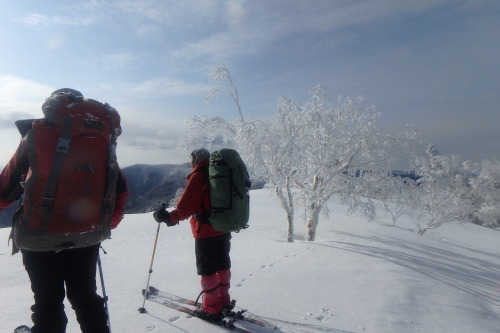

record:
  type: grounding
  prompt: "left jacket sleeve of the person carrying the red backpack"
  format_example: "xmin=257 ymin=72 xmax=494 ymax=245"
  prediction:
xmin=0 ymin=140 xmax=29 ymax=210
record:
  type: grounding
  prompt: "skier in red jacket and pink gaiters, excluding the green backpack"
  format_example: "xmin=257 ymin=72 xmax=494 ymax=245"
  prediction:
xmin=154 ymin=148 xmax=231 ymax=322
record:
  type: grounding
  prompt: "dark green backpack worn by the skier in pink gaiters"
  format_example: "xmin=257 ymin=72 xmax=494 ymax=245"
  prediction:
xmin=208 ymin=148 xmax=251 ymax=232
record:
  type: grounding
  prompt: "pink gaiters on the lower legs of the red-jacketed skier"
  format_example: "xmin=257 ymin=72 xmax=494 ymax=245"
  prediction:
xmin=201 ymin=269 xmax=231 ymax=314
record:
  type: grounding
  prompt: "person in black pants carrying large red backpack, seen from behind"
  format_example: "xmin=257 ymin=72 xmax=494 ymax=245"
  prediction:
xmin=0 ymin=88 xmax=128 ymax=333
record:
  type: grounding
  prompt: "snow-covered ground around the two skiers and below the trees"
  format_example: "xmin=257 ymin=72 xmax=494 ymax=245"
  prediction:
xmin=0 ymin=190 xmax=500 ymax=333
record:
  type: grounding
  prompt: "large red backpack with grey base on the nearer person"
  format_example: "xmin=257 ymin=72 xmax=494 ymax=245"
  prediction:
xmin=13 ymin=92 xmax=121 ymax=251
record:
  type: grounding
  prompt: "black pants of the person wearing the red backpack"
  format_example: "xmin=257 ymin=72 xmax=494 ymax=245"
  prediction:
xmin=22 ymin=245 xmax=109 ymax=333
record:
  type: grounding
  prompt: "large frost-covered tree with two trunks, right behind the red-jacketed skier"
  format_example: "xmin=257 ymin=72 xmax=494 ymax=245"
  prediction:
xmin=183 ymin=66 xmax=420 ymax=242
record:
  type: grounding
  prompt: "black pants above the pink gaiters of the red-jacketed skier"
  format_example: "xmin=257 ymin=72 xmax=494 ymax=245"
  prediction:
xmin=195 ymin=233 xmax=231 ymax=276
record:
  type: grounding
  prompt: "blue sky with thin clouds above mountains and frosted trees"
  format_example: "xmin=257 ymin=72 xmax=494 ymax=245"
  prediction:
xmin=0 ymin=0 xmax=500 ymax=166
